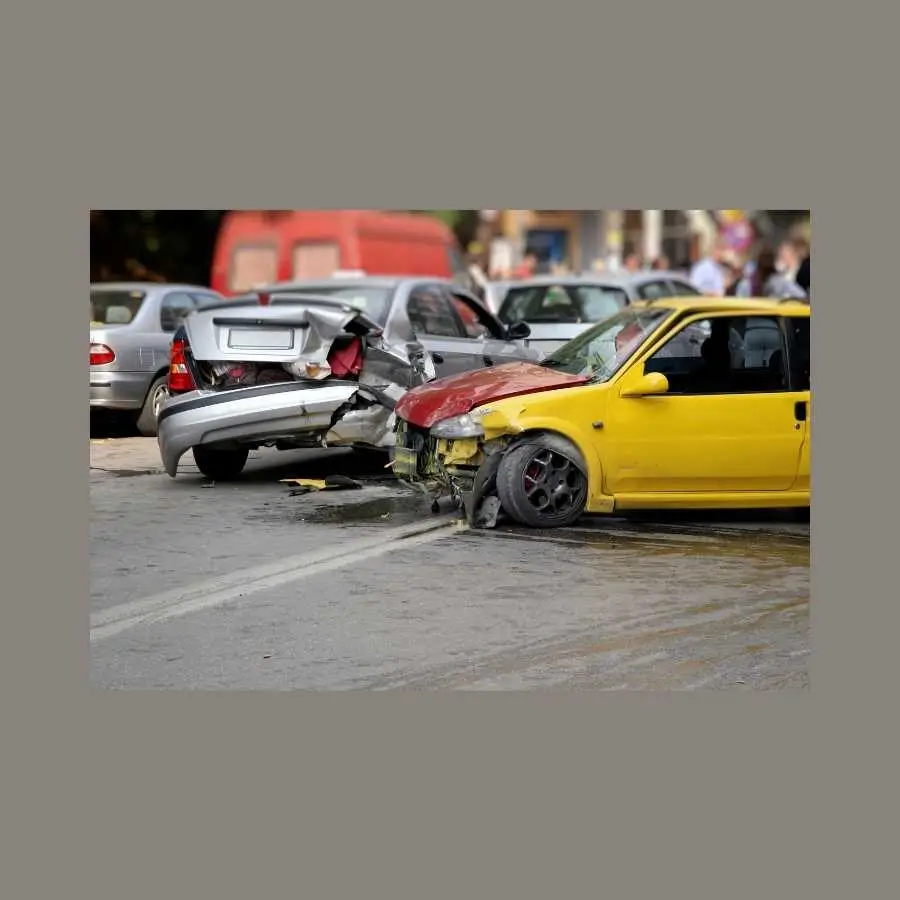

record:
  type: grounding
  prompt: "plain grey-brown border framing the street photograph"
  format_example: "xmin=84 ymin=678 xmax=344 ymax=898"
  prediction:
xmin=2 ymin=0 xmax=884 ymax=898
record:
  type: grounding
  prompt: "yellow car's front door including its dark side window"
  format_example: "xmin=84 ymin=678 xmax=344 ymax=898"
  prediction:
xmin=602 ymin=313 xmax=805 ymax=503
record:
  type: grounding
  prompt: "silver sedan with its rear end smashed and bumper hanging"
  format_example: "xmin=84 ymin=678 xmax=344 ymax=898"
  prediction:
xmin=158 ymin=278 xmax=542 ymax=480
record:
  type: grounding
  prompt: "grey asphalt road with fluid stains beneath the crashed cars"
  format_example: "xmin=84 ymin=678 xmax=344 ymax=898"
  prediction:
xmin=90 ymin=437 xmax=810 ymax=690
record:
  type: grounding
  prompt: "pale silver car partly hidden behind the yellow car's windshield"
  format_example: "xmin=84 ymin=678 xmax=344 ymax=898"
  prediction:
xmin=491 ymin=272 xmax=700 ymax=353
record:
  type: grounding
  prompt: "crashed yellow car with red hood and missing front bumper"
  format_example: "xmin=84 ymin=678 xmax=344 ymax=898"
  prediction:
xmin=394 ymin=297 xmax=811 ymax=528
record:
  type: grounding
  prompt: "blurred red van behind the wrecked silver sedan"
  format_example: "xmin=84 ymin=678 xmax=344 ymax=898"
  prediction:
xmin=210 ymin=209 xmax=467 ymax=296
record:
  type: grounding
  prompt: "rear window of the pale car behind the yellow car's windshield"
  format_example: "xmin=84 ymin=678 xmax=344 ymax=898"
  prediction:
xmin=500 ymin=284 xmax=628 ymax=325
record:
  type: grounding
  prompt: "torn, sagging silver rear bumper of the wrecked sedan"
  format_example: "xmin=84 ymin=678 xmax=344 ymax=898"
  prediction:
xmin=157 ymin=380 xmax=394 ymax=478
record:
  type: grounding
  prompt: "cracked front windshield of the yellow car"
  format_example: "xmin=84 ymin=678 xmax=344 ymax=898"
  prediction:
xmin=541 ymin=308 xmax=672 ymax=382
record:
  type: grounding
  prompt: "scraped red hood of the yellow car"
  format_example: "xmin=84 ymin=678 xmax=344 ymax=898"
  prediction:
xmin=396 ymin=362 xmax=588 ymax=428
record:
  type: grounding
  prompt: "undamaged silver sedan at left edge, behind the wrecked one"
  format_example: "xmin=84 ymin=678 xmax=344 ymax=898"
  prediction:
xmin=90 ymin=282 xmax=224 ymax=435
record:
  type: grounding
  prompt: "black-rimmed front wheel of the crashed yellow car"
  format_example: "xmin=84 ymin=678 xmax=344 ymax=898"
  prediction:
xmin=497 ymin=434 xmax=588 ymax=528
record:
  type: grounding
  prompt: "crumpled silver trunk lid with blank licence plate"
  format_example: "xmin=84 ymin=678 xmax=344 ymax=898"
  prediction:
xmin=184 ymin=298 xmax=377 ymax=364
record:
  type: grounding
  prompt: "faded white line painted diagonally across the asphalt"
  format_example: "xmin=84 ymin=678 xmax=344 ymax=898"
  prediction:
xmin=91 ymin=517 xmax=465 ymax=644
